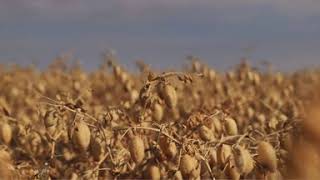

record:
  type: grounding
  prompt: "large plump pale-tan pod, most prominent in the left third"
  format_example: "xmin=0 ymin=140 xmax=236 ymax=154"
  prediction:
xmin=72 ymin=121 xmax=91 ymax=151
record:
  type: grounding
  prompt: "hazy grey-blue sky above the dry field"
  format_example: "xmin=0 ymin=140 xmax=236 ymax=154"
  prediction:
xmin=0 ymin=0 xmax=320 ymax=70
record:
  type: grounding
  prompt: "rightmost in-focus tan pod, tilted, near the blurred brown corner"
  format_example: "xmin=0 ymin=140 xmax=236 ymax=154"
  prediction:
xmin=257 ymin=141 xmax=277 ymax=172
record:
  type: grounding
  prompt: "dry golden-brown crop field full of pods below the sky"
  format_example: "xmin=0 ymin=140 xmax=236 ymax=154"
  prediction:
xmin=0 ymin=56 xmax=320 ymax=180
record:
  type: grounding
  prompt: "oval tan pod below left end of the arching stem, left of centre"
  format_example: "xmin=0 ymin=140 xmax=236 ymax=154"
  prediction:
xmin=129 ymin=136 xmax=145 ymax=164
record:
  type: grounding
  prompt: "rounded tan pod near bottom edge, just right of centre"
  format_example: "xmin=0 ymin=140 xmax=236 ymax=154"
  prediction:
xmin=179 ymin=154 xmax=198 ymax=178
